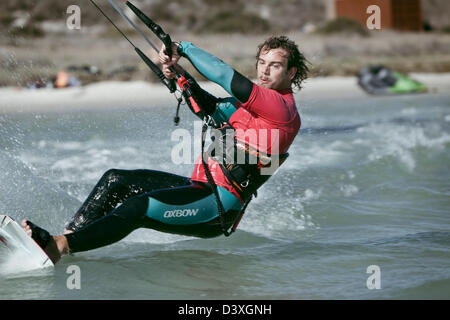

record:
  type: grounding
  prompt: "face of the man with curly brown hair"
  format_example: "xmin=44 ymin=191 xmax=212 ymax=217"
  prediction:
xmin=256 ymin=48 xmax=297 ymax=90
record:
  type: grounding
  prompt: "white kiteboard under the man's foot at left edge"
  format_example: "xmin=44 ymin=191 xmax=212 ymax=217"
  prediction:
xmin=0 ymin=215 xmax=54 ymax=268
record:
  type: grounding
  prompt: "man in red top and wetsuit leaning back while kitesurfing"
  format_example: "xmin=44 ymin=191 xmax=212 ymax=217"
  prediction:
xmin=22 ymin=36 xmax=308 ymax=262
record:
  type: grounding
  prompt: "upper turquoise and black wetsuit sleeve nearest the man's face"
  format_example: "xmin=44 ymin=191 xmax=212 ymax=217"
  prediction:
xmin=178 ymin=41 xmax=253 ymax=103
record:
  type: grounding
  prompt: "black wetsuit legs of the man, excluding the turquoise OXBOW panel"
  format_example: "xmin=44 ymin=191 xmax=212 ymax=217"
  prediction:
xmin=66 ymin=169 xmax=243 ymax=252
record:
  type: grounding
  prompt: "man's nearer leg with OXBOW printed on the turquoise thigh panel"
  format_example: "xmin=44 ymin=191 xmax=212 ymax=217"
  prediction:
xmin=22 ymin=183 xmax=241 ymax=263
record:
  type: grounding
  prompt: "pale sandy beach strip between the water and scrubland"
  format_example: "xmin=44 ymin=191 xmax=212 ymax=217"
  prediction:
xmin=0 ymin=73 xmax=450 ymax=113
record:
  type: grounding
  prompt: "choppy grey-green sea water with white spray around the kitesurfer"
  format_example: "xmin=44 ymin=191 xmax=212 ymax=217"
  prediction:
xmin=0 ymin=89 xmax=450 ymax=299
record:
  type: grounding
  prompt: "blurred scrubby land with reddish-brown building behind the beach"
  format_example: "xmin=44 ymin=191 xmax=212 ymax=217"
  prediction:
xmin=0 ymin=0 xmax=450 ymax=86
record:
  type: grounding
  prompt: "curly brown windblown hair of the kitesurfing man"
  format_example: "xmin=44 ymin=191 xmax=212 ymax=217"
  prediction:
xmin=256 ymin=36 xmax=309 ymax=90
